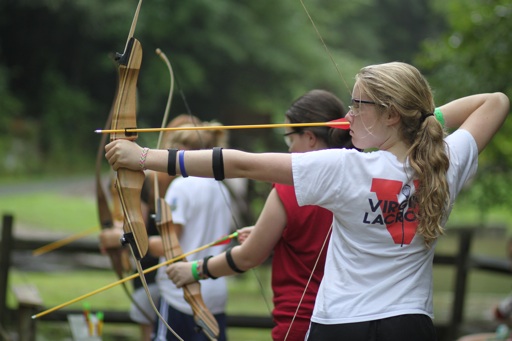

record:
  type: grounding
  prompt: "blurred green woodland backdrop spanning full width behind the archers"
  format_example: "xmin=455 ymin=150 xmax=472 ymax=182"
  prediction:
xmin=0 ymin=0 xmax=512 ymax=338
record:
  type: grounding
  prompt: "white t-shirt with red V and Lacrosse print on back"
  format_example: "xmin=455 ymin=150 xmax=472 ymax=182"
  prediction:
xmin=292 ymin=130 xmax=478 ymax=324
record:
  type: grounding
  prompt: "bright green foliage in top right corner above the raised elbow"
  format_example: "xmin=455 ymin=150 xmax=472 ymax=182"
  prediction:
xmin=417 ymin=0 xmax=512 ymax=98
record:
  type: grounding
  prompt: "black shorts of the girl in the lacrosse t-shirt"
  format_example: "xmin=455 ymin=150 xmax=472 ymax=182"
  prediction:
xmin=307 ymin=314 xmax=437 ymax=341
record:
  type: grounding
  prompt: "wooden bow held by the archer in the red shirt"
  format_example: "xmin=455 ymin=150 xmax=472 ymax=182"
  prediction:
xmin=154 ymin=49 xmax=219 ymax=340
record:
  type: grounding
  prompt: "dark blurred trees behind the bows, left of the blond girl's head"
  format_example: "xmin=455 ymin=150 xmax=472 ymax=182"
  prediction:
xmin=0 ymin=0 xmax=444 ymax=172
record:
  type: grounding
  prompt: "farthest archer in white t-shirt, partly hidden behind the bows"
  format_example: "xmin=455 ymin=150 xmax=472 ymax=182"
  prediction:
xmin=149 ymin=118 xmax=231 ymax=341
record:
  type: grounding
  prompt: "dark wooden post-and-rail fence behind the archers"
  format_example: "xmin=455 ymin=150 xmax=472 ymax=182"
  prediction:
xmin=0 ymin=215 xmax=512 ymax=341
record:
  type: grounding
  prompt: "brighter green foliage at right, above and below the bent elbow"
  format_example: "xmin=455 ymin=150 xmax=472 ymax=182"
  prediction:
xmin=417 ymin=0 xmax=512 ymax=221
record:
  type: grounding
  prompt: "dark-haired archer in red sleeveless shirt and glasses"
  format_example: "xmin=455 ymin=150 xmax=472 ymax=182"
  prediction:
xmin=169 ymin=89 xmax=353 ymax=340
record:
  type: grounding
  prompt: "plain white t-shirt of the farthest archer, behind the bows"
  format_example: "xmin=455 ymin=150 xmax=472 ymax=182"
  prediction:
xmin=156 ymin=177 xmax=231 ymax=315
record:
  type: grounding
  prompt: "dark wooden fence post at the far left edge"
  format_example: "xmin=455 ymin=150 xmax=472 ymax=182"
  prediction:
xmin=0 ymin=214 xmax=14 ymax=326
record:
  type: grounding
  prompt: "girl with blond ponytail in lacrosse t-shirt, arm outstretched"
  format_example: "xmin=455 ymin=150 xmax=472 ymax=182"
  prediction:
xmin=105 ymin=62 xmax=510 ymax=341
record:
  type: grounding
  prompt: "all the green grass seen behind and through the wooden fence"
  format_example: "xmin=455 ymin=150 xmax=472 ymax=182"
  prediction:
xmin=0 ymin=179 xmax=512 ymax=341
